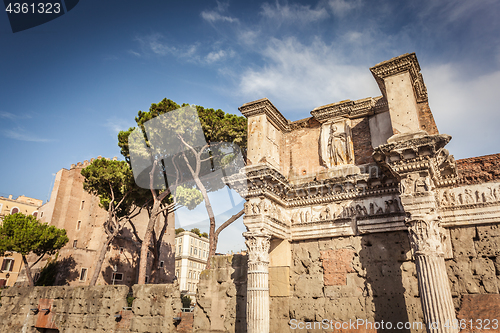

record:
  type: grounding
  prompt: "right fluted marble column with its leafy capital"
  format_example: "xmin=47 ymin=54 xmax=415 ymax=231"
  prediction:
xmin=406 ymin=213 xmax=459 ymax=333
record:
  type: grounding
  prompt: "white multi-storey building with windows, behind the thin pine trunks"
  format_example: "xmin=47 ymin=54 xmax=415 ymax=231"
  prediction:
xmin=175 ymin=231 xmax=209 ymax=301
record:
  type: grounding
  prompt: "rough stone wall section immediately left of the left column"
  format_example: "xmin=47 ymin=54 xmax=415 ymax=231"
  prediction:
xmin=193 ymin=254 xmax=247 ymax=333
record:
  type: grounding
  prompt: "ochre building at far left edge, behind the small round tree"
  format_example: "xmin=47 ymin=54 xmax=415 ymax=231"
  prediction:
xmin=0 ymin=195 xmax=43 ymax=288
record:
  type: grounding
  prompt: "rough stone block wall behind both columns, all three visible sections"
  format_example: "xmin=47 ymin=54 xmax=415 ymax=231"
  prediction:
xmin=193 ymin=225 xmax=500 ymax=333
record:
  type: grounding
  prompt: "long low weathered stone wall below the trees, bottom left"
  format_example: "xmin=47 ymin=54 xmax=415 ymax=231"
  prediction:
xmin=0 ymin=284 xmax=181 ymax=333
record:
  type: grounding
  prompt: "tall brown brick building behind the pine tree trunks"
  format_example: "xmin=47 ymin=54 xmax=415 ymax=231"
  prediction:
xmin=30 ymin=157 xmax=175 ymax=286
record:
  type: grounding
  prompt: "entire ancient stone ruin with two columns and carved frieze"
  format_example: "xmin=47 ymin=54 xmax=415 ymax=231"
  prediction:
xmin=205 ymin=53 xmax=500 ymax=333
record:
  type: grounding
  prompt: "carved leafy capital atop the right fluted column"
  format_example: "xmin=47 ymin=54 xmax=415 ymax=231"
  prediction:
xmin=405 ymin=212 xmax=444 ymax=256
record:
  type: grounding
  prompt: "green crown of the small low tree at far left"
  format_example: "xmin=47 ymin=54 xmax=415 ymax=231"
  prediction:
xmin=0 ymin=213 xmax=69 ymax=256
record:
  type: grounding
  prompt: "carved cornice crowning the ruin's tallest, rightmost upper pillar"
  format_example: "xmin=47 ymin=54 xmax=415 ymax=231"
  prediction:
xmin=370 ymin=53 xmax=427 ymax=102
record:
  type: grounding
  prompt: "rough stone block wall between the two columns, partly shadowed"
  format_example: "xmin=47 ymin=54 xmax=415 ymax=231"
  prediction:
xmin=288 ymin=232 xmax=425 ymax=332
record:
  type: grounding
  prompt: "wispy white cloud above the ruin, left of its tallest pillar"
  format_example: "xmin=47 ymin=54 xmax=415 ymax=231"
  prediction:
xmin=239 ymin=38 xmax=380 ymax=115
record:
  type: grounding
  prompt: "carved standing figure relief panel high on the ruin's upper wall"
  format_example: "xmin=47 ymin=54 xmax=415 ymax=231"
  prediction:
xmin=320 ymin=122 xmax=354 ymax=168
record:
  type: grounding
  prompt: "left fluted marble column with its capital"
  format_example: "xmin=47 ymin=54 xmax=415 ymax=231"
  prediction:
xmin=243 ymin=232 xmax=271 ymax=333
